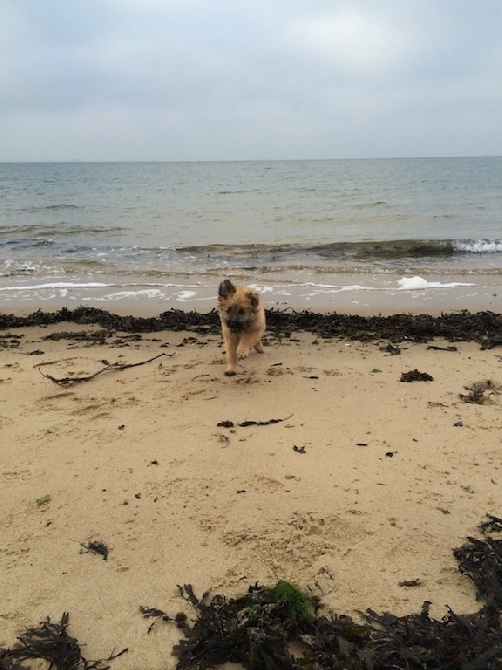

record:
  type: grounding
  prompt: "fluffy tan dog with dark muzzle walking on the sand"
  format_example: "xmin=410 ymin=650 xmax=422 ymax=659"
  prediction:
xmin=218 ymin=279 xmax=265 ymax=376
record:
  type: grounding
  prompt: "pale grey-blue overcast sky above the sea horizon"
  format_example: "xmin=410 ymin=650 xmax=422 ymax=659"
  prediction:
xmin=0 ymin=0 xmax=502 ymax=161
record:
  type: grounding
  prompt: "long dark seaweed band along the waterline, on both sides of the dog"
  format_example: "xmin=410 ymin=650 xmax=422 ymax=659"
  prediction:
xmin=0 ymin=307 xmax=502 ymax=349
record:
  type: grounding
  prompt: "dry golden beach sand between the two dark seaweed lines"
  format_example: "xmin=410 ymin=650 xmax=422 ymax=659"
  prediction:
xmin=0 ymin=324 xmax=502 ymax=670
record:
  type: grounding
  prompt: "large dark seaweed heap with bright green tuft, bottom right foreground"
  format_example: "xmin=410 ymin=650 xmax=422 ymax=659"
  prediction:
xmin=166 ymin=515 xmax=502 ymax=670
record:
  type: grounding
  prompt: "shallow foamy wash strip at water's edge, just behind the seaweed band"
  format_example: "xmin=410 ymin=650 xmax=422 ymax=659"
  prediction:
xmin=0 ymin=274 xmax=502 ymax=317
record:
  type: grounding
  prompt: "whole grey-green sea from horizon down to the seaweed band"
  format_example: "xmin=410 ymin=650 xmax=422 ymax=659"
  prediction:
xmin=0 ymin=156 xmax=502 ymax=315
